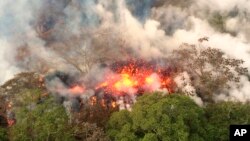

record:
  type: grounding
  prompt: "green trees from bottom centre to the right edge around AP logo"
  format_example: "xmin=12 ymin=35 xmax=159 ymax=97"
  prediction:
xmin=107 ymin=93 xmax=250 ymax=141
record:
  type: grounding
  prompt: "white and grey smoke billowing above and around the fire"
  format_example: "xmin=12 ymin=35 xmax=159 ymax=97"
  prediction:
xmin=0 ymin=0 xmax=250 ymax=104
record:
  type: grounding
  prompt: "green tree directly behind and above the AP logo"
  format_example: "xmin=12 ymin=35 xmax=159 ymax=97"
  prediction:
xmin=205 ymin=102 xmax=250 ymax=141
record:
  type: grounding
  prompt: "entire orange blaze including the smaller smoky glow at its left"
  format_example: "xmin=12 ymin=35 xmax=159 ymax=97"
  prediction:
xmin=46 ymin=61 xmax=175 ymax=109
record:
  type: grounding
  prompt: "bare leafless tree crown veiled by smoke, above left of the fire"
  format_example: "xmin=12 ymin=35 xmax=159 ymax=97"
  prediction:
xmin=49 ymin=28 xmax=131 ymax=75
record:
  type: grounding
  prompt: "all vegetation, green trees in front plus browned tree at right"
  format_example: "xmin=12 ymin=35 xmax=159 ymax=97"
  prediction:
xmin=0 ymin=45 xmax=250 ymax=141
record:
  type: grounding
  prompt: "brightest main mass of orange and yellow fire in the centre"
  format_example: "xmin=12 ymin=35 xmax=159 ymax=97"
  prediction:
xmin=96 ymin=62 xmax=174 ymax=95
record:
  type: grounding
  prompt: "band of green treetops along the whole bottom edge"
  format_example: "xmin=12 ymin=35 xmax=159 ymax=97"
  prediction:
xmin=0 ymin=90 xmax=250 ymax=141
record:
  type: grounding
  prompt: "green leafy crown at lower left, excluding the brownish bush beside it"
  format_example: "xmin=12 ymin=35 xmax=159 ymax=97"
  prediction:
xmin=10 ymin=94 xmax=73 ymax=141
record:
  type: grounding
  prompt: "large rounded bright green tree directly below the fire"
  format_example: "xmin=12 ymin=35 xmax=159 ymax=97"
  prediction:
xmin=107 ymin=93 xmax=205 ymax=141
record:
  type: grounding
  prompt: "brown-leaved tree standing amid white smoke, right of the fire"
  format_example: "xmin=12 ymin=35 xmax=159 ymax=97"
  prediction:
xmin=170 ymin=42 xmax=247 ymax=102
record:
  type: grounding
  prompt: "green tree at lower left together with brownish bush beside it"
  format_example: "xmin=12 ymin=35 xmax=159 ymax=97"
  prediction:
xmin=10 ymin=89 xmax=108 ymax=141
